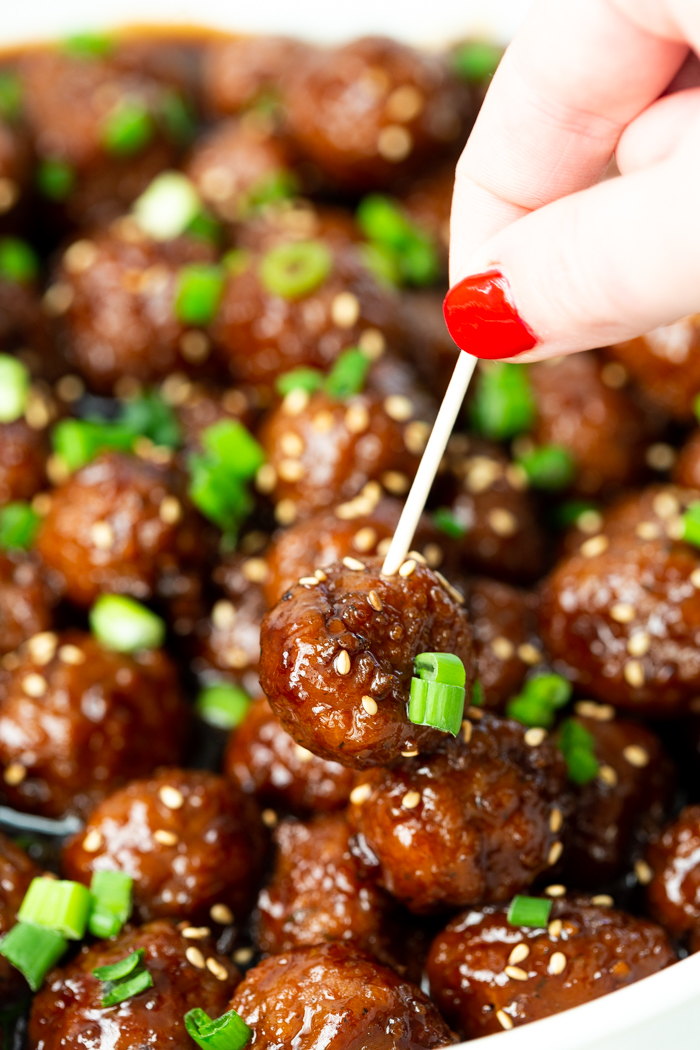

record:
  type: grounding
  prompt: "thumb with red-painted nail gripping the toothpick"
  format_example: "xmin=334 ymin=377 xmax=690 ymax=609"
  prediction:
xmin=445 ymin=113 xmax=700 ymax=361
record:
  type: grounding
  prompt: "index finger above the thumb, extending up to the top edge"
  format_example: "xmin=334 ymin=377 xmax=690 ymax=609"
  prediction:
xmin=450 ymin=0 xmax=688 ymax=282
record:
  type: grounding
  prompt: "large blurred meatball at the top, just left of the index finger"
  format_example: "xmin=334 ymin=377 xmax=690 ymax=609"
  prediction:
xmin=284 ymin=37 xmax=466 ymax=190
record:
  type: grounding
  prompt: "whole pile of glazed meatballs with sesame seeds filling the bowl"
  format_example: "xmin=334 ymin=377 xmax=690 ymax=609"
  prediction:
xmin=0 ymin=22 xmax=700 ymax=1050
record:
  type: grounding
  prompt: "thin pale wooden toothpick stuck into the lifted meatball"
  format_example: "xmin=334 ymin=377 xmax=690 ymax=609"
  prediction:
xmin=382 ymin=353 xmax=478 ymax=576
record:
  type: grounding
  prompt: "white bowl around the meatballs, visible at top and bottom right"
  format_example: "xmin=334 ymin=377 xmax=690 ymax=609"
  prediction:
xmin=5 ymin=0 xmax=700 ymax=1050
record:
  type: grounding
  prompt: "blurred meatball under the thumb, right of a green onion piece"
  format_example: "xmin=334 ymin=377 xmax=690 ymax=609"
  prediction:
xmin=529 ymin=351 xmax=650 ymax=496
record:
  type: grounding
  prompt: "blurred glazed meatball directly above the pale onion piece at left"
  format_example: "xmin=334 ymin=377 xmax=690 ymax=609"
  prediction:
xmin=37 ymin=453 xmax=201 ymax=605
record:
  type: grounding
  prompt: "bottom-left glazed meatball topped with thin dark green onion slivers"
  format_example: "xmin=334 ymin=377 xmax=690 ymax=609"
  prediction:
xmin=28 ymin=920 xmax=240 ymax=1050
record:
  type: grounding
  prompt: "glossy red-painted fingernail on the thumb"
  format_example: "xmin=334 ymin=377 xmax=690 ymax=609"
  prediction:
xmin=443 ymin=270 xmax=537 ymax=361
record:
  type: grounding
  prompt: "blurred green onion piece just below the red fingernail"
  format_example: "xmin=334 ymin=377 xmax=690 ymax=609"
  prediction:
xmin=471 ymin=361 xmax=535 ymax=441
